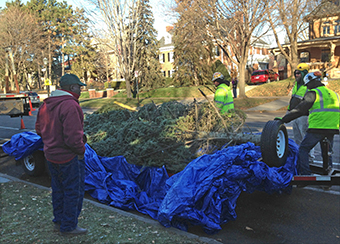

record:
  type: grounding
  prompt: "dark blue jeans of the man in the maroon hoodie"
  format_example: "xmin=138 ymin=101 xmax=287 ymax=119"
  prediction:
xmin=47 ymin=156 xmax=85 ymax=232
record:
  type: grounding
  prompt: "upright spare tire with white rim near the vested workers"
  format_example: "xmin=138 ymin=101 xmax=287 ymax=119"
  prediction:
xmin=260 ymin=120 xmax=288 ymax=167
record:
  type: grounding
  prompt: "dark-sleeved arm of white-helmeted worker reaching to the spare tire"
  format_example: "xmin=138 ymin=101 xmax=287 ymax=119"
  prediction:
xmin=282 ymin=91 xmax=316 ymax=123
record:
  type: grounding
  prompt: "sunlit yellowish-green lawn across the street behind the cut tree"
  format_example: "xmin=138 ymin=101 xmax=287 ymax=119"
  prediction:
xmin=80 ymin=79 xmax=340 ymax=110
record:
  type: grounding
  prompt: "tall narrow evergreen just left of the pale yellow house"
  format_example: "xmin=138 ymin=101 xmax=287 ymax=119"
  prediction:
xmin=135 ymin=0 xmax=164 ymax=89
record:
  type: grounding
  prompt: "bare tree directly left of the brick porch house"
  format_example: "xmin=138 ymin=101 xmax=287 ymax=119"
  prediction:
xmin=268 ymin=0 xmax=321 ymax=73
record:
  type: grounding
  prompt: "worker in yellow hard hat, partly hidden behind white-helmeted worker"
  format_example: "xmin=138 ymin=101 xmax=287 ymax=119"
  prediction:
xmin=288 ymin=63 xmax=314 ymax=163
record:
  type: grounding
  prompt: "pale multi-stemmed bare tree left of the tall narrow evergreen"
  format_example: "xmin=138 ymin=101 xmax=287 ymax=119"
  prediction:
xmin=90 ymin=0 xmax=140 ymax=98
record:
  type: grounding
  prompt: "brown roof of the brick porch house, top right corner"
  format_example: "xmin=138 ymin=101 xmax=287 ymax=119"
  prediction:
xmin=304 ymin=0 xmax=340 ymax=21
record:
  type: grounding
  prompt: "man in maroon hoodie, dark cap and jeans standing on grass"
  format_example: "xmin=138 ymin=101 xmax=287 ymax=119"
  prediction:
xmin=35 ymin=74 xmax=87 ymax=235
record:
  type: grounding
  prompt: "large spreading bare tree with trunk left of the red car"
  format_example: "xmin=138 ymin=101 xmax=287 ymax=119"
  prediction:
xmin=205 ymin=0 xmax=275 ymax=98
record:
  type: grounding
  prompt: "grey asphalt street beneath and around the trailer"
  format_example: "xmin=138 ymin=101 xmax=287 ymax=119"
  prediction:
xmin=0 ymin=111 xmax=340 ymax=244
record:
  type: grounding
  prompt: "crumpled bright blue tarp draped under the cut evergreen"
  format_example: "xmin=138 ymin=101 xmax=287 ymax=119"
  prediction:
xmin=3 ymin=132 xmax=298 ymax=233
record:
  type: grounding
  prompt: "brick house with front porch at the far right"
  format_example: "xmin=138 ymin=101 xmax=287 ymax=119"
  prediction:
xmin=272 ymin=0 xmax=340 ymax=78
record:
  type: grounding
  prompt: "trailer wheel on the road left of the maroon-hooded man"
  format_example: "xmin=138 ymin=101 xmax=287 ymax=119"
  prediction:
xmin=20 ymin=150 xmax=46 ymax=176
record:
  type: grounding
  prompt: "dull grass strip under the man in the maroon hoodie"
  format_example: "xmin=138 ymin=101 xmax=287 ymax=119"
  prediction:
xmin=0 ymin=182 xmax=204 ymax=244
